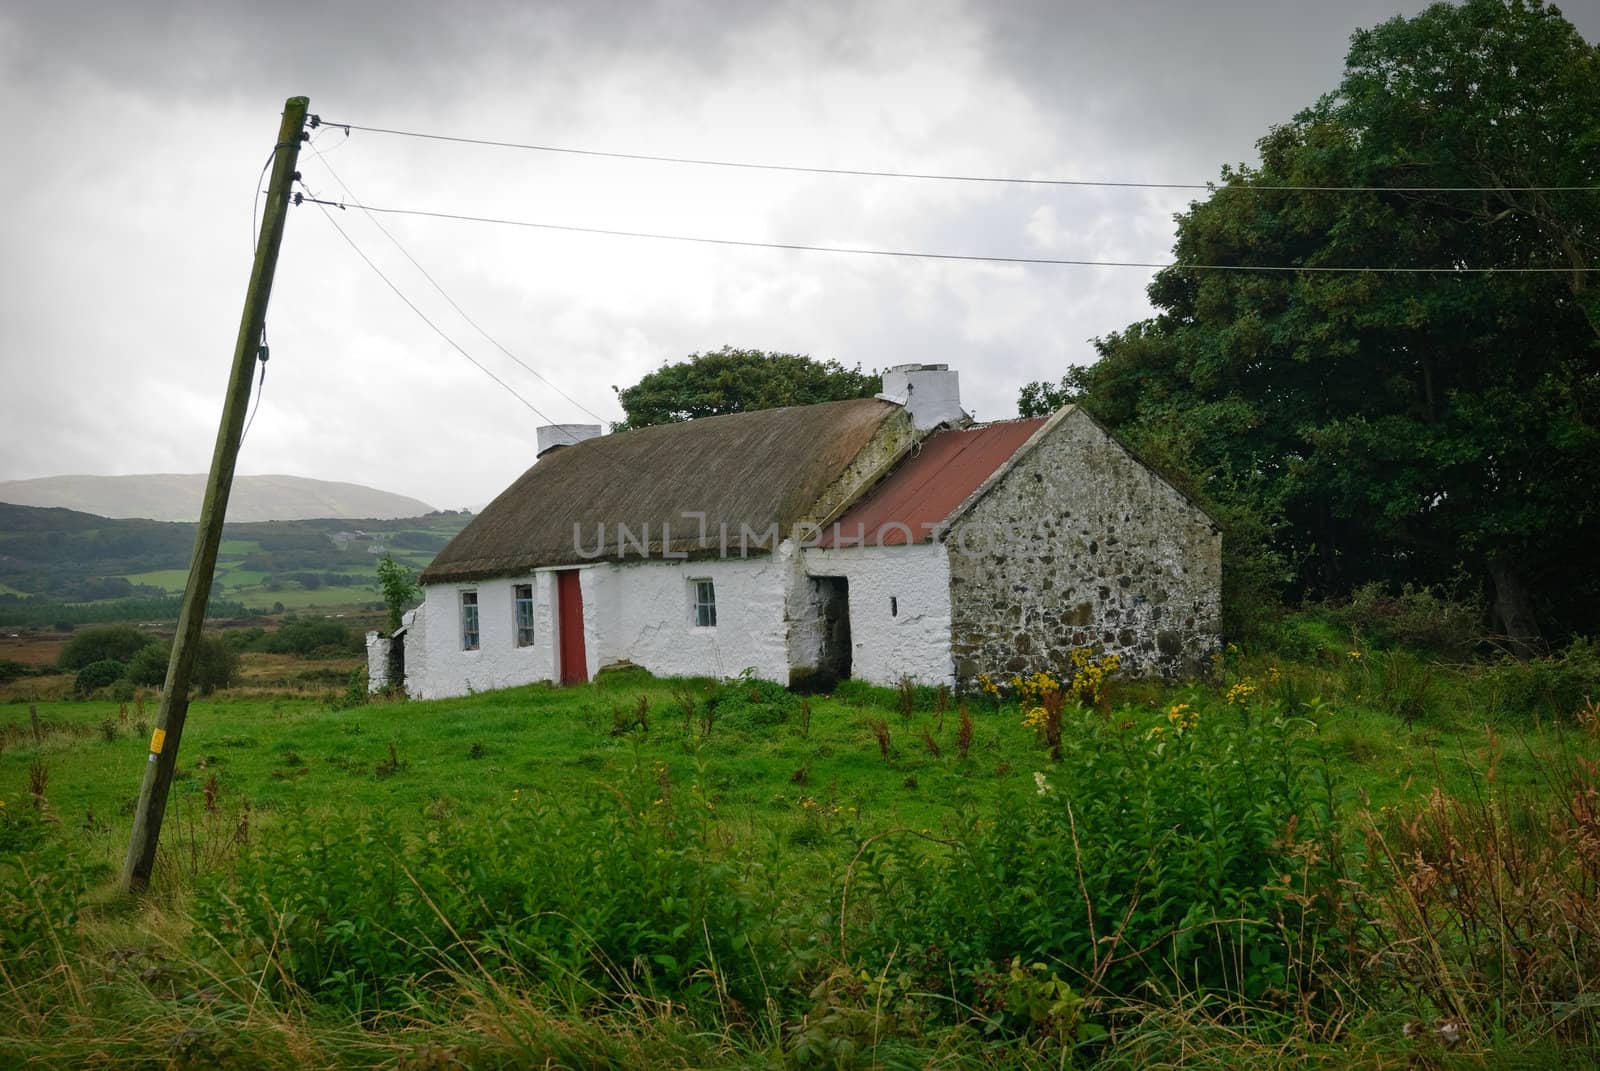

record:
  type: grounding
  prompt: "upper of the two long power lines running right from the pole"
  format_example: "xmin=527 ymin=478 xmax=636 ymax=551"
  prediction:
xmin=310 ymin=115 xmax=1600 ymax=194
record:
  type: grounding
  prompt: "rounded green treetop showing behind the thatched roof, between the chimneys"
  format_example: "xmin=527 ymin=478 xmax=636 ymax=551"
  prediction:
xmin=614 ymin=346 xmax=883 ymax=431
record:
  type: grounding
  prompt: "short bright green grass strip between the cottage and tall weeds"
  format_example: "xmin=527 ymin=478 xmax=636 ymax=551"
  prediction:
xmin=12 ymin=679 xmax=1043 ymax=860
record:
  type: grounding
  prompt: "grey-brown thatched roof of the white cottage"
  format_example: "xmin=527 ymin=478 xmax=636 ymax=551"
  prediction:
xmin=422 ymin=399 xmax=899 ymax=583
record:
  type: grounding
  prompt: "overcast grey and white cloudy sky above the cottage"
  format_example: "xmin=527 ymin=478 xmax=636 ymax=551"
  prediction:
xmin=0 ymin=0 xmax=1600 ymax=507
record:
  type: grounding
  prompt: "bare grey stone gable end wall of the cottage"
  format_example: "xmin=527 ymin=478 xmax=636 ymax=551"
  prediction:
xmin=946 ymin=410 xmax=1222 ymax=685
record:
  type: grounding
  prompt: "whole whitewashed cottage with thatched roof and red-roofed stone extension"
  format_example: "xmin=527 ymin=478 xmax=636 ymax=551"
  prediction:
xmin=368 ymin=365 xmax=1221 ymax=698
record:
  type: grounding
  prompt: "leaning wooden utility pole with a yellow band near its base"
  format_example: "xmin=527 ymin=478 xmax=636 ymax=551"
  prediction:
xmin=122 ymin=96 xmax=310 ymax=893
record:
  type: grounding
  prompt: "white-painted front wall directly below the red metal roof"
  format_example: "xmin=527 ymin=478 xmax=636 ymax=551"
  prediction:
xmin=803 ymin=543 xmax=955 ymax=685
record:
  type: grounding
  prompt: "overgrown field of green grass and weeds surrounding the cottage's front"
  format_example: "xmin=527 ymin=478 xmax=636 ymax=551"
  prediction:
xmin=0 ymin=640 xmax=1600 ymax=1068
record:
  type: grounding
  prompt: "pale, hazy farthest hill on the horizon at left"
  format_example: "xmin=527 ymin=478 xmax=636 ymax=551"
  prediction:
xmin=0 ymin=474 xmax=434 ymax=522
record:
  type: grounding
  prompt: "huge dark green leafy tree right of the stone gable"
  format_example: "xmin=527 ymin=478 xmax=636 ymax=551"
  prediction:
xmin=1035 ymin=0 xmax=1600 ymax=650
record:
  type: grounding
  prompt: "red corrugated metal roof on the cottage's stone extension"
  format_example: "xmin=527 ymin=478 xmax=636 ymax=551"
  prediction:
xmin=819 ymin=416 xmax=1050 ymax=546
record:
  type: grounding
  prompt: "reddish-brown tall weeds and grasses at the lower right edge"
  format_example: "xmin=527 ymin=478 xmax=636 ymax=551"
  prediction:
xmin=1365 ymin=730 xmax=1600 ymax=1042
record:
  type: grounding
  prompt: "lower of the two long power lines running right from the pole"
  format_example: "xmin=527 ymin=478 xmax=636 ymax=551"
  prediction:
xmin=294 ymin=197 xmax=1600 ymax=275
